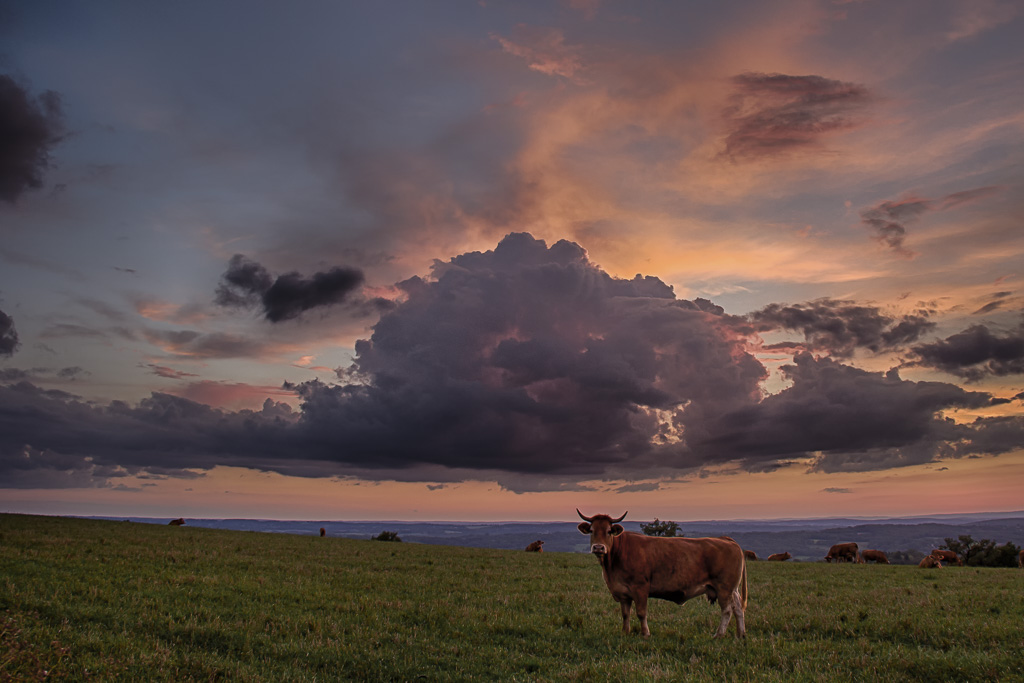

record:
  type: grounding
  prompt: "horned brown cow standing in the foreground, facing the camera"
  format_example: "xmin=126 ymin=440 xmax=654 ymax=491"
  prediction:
xmin=577 ymin=509 xmax=746 ymax=638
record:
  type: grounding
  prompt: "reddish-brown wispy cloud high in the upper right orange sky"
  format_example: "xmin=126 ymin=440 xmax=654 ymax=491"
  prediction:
xmin=724 ymin=73 xmax=870 ymax=159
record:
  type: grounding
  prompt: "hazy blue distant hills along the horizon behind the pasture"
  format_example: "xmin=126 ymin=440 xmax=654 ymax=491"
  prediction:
xmin=90 ymin=511 xmax=1024 ymax=561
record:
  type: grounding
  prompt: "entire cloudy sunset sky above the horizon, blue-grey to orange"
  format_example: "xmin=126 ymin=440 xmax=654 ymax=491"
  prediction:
xmin=0 ymin=0 xmax=1024 ymax=521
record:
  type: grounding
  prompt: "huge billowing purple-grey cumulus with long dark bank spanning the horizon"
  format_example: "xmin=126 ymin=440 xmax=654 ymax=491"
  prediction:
xmin=0 ymin=233 xmax=1021 ymax=490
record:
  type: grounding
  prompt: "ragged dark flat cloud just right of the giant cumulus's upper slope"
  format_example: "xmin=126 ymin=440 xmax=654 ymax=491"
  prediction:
xmin=748 ymin=299 xmax=935 ymax=357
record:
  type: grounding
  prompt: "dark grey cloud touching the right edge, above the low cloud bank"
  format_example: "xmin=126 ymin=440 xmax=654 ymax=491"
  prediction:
xmin=907 ymin=325 xmax=1024 ymax=382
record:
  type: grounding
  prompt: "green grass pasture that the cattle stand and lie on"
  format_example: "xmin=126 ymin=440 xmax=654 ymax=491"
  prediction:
xmin=0 ymin=515 xmax=1024 ymax=681
